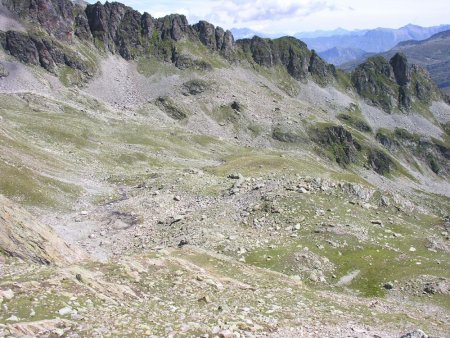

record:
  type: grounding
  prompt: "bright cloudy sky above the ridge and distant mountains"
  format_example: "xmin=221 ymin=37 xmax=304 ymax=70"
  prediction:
xmin=90 ymin=0 xmax=450 ymax=34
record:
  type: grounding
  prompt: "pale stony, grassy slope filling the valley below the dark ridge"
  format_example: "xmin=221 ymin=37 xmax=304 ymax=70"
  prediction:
xmin=0 ymin=46 xmax=450 ymax=337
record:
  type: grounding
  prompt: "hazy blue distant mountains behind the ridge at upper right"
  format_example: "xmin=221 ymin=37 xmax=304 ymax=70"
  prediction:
xmin=231 ymin=24 xmax=450 ymax=66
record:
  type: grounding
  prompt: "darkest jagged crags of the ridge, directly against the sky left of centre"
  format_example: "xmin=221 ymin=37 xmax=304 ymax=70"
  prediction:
xmin=85 ymin=2 xmax=234 ymax=60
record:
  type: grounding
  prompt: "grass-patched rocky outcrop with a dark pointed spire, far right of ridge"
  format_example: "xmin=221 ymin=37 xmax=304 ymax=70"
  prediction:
xmin=352 ymin=53 xmax=440 ymax=113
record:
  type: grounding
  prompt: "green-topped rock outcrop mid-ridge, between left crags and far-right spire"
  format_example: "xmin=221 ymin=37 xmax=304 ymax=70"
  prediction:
xmin=237 ymin=36 xmax=333 ymax=84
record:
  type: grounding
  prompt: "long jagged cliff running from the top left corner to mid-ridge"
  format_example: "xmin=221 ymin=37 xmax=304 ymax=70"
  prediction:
xmin=3 ymin=0 xmax=235 ymax=60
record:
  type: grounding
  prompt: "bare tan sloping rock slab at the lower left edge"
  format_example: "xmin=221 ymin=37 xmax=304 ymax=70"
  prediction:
xmin=0 ymin=195 xmax=87 ymax=264
